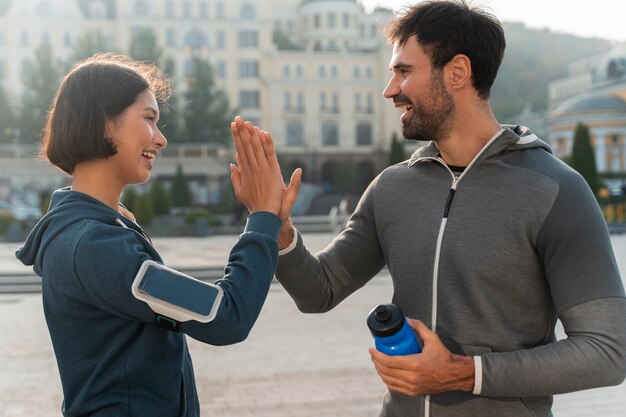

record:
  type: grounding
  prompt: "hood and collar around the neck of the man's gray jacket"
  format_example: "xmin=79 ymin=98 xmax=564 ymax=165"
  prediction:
xmin=409 ymin=125 xmax=552 ymax=167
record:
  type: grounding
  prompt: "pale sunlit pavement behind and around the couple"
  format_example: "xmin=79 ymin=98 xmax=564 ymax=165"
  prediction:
xmin=0 ymin=233 xmax=626 ymax=417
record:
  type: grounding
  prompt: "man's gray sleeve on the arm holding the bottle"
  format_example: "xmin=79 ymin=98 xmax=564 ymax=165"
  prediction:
xmin=481 ymin=167 xmax=626 ymax=397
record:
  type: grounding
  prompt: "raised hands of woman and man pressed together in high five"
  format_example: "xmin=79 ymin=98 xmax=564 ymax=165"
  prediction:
xmin=230 ymin=116 xmax=302 ymax=219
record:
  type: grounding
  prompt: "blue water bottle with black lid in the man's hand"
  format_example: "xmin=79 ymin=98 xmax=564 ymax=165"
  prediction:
xmin=367 ymin=304 xmax=422 ymax=356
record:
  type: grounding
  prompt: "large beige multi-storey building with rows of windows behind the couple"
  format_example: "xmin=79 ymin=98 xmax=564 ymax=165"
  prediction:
xmin=0 ymin=0 xmax=400 ymax=192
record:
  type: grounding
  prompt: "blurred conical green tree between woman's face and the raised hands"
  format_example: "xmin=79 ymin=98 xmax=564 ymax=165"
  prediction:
xmin=182 ymin=57 xmax=235 ymax=144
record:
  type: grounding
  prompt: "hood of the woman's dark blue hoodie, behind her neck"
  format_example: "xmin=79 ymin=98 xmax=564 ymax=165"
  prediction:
xmin=15 ymin=187 xmax=141 ymax=276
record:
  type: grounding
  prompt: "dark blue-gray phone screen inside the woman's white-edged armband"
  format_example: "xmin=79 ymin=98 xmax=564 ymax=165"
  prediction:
xmin=139 ymin=266 xmax=219 ymax=316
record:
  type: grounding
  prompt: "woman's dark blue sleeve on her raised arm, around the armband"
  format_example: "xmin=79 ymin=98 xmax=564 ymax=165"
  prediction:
xmin=74 ymin=213 xmax=280 ymax=345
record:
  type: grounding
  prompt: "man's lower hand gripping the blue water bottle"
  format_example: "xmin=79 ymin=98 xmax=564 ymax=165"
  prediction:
xmin=369 ymin=319 xmax=474 ymax=395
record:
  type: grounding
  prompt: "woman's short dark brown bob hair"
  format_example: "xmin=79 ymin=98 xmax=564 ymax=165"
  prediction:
xmin=41 ymin=54 xmax=171 ymax=175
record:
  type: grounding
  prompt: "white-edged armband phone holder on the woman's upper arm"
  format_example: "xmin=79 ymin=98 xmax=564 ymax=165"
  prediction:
xmin=132 ymin=261 xmax=224 ymax=323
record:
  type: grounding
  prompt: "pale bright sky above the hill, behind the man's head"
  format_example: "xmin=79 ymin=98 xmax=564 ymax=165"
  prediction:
xmin=360 ymin=0 xmax=626 ymax=42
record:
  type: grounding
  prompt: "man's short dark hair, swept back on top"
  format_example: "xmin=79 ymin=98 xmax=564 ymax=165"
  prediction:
xmin=385 ymin=0 xmax=506 ymax=99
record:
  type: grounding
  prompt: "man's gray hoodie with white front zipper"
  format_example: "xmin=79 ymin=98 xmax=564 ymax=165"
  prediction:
xmin=276 ymin=126 xmax=626 ymax=417
